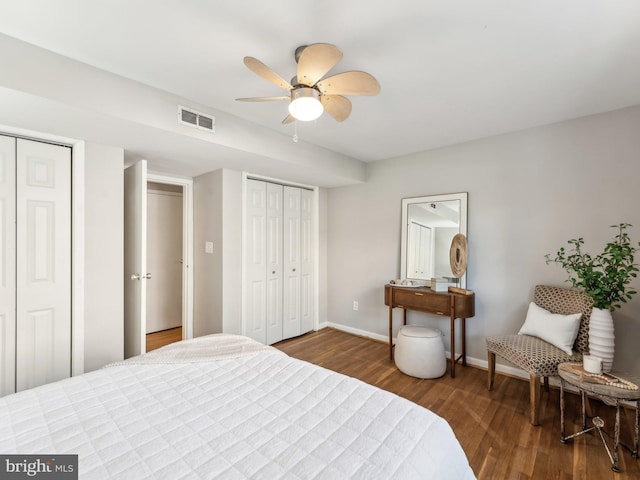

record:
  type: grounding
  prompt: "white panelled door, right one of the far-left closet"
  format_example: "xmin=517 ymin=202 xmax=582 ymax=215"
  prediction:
xmin=16 ymin=139 xmax=71 ymax=391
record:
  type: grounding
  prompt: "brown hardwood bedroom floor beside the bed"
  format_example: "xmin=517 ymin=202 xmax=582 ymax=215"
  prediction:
xmin=274 ymin=328 xmax=640 ymax=480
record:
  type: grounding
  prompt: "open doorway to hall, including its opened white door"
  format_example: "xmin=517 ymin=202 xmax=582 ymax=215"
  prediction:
xmin=125 ymin=160 xmax=193 ymax=358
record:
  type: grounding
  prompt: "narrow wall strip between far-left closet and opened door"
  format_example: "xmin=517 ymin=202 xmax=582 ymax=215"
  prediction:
xmin=84 ymin=143 xmax=124 ymax=372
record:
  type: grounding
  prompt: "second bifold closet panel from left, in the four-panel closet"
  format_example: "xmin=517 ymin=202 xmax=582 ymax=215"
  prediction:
xmin=266 ymin=183 xmax=283 ymax=345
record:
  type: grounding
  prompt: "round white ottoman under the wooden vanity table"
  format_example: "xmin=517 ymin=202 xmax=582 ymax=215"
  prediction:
xmin=393 ymin=325 xmax=447 ymax=378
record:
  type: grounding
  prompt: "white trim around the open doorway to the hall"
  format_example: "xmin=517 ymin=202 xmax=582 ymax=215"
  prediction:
xmin=143 ymin=173 xmax=194 ymax=340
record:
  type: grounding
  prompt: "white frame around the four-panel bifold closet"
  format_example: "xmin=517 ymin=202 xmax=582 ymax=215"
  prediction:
xmin=240 ymin=172 xmax=320 ymax=342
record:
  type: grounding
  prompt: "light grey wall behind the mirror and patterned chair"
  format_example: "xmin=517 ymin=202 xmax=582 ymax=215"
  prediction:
xmin=327 ymin=107 xmax=640 ymax=374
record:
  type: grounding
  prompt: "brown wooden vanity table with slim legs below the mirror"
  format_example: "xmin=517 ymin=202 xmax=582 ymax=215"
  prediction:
xmin=384 ymin=285 xmax=475 ymax=377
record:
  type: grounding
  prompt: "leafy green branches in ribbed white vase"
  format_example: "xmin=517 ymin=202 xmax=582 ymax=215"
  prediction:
xmin=545 ymin=223 xmax=640 ymax=371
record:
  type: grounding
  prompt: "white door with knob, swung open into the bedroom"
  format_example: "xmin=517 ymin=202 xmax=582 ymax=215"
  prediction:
xmin=124 ymin=160 xmax=147 ymax=358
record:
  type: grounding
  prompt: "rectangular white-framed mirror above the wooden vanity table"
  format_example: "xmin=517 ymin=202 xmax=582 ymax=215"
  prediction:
xmin=400 ymin=192 xmax=467 ymax=288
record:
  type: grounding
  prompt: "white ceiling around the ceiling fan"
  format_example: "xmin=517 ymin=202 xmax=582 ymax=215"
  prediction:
xmin=0 ymin=0 xmax=640 ymax=178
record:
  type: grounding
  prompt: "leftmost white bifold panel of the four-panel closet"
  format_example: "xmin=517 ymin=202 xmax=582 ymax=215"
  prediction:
xmin=245 ymin=180 xmax=267 ymax=344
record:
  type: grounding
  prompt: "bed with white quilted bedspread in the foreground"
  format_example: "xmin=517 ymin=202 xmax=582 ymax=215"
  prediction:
xmin=0 ymin=334 xmax=475 ymax=480
